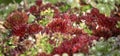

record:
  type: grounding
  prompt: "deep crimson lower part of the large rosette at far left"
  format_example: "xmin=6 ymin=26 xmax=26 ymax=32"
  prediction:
xmin=12 ymin=24 xmax=27 ymax=36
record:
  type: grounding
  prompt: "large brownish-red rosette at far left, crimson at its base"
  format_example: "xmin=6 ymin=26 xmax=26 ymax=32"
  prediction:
xmin=4 ymin=10 xmax=28 ymax=36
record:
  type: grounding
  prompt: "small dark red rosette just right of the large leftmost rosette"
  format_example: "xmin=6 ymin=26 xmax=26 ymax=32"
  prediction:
xmin=28 ymin=23 xmax=43 ymax=34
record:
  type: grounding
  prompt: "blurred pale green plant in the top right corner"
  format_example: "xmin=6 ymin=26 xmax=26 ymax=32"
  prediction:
xmin=85 ymin=0 xmax=120 ymax=16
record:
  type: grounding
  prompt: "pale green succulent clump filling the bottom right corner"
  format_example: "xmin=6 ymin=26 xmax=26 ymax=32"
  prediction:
xmin=89 ymin=37 xmax=120 ymax=56
